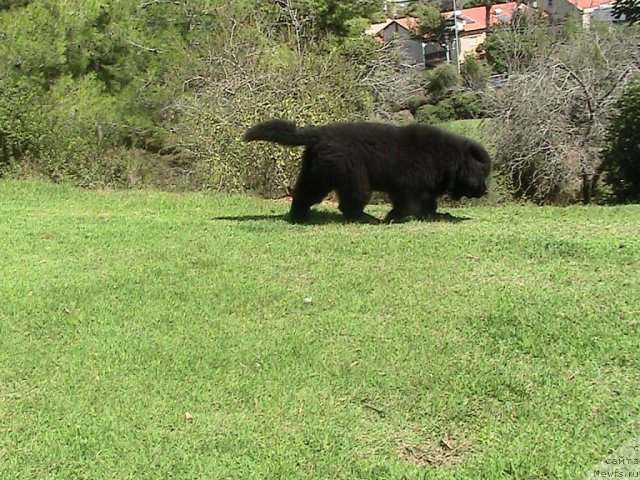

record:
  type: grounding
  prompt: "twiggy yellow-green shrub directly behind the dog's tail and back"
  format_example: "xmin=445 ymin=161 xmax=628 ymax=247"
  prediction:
xmin=176 ymin=42 xmax=371 ymax=196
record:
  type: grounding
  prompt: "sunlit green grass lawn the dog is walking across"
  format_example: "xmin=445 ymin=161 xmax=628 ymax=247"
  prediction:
xmin=0 ymin=181 xmax=640 ymax=480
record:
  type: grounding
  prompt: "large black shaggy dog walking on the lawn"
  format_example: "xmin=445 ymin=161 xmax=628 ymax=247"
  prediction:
xmin=244 ymin=119 xmax=491 ymax=223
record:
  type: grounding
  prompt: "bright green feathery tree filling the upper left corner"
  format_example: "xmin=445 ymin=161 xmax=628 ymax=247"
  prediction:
xmin=0 ymin=0 xmax=260 ymax=184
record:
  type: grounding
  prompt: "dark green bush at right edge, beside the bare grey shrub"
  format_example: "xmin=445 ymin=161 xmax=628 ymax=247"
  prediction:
xmin=603 ymin=77 xmax=640 ymax=202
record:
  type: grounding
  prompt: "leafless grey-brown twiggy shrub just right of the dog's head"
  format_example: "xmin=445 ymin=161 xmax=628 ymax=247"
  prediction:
xmin=492 ymin=25 xmax=638 ymax=203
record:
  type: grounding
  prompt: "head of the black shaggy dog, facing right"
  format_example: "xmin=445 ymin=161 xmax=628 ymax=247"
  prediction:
xmin=447 ymin=143 xmax=491 ymax=200
